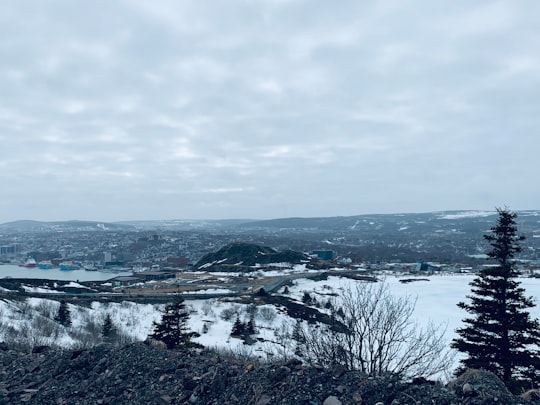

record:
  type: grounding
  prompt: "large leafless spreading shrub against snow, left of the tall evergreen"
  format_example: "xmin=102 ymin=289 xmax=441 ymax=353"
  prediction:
xmin=296 ymin=283 xmax=452 ymax=377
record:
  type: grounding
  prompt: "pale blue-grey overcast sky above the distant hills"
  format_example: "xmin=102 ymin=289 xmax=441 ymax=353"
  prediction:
xmin=0 ymin=0 xmax=540 ymax=222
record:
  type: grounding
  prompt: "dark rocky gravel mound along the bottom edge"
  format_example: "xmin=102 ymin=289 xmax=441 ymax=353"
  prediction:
xmin=0 ymin=343 xmax=540 ymax=405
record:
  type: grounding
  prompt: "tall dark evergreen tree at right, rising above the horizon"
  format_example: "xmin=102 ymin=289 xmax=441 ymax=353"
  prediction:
xmin=451 ymin=209 xmax=540 ymax=384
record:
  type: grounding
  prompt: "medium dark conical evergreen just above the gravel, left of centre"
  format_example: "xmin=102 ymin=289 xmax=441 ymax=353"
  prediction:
xmin=150 ymin=296 xmax=202 ymax=349
